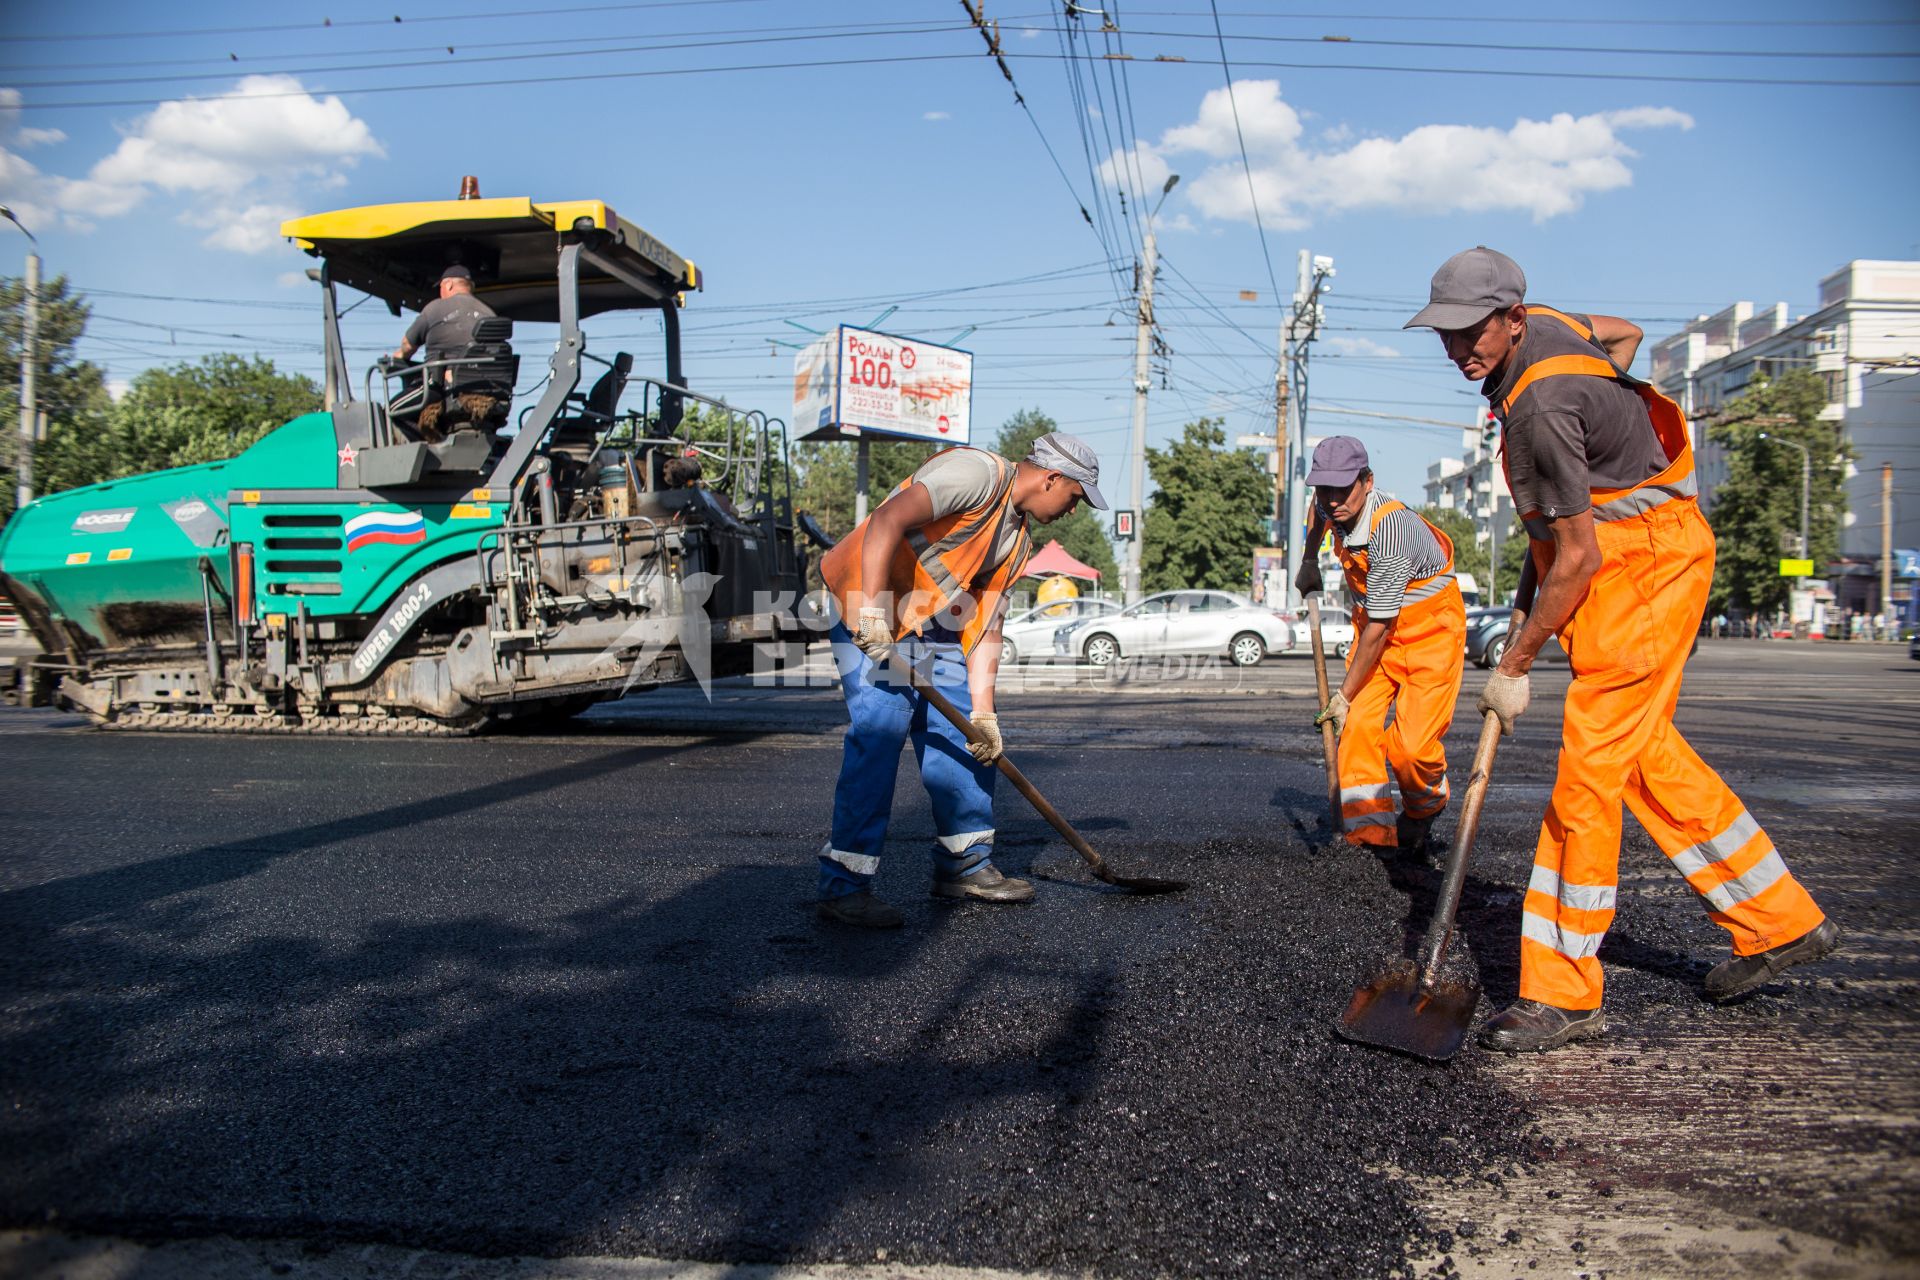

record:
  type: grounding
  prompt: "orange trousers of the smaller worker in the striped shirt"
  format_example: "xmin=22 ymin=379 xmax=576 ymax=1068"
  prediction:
xmin=1340 ymin=583 xmax=1467 ymax=848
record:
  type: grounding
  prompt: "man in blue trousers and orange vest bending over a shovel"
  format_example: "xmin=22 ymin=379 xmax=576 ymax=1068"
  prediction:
xmin=818 ymin=432 xmax=1106 ymax=929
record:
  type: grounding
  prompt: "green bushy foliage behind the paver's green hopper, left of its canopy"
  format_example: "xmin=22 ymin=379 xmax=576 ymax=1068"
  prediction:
xmin=35 ymin=353 xmax=321 ymax=493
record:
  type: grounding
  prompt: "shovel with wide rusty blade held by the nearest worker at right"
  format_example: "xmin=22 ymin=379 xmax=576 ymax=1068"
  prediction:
xmin=1336 ymin=714 xmax=1500 ymax=1063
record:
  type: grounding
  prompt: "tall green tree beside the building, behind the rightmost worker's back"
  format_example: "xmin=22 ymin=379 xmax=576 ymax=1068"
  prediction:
xmin=1707 ymin=368 xmax=1853 ymax=614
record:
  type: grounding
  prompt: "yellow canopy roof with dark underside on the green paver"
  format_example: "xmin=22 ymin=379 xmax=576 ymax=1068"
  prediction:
xmin=280 ymin=196 xmax=701 ymax=320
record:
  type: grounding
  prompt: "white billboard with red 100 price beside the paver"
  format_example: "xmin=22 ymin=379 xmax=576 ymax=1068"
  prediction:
xmin=793 ymin=324 xmax=973 ymax=445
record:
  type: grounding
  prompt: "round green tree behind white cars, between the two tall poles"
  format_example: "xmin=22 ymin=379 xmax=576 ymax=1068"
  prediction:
xmin=1140 ymin=418 xmax=1273 ymax=591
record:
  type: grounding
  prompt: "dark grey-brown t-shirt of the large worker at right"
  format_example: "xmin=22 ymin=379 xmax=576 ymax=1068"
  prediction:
xmin=1480 ymin=313 xmax=1667 ymax=539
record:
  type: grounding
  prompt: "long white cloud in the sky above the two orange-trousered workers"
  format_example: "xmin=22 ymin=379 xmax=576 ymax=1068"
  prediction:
xmin=1102 ymin=81 xmax=1693 ymax=230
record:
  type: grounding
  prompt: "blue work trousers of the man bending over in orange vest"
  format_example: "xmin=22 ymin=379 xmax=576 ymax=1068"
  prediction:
xmin=820 ymin=624 xmax=998 ymax=898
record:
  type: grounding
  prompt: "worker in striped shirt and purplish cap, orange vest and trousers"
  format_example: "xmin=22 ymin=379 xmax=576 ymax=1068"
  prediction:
xmin=1294 ymin=436 xmax=1467 ymax=850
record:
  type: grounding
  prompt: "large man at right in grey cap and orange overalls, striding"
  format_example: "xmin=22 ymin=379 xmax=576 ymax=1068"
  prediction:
xmin=1407 ymin=246 xmax=1839 ymax=1052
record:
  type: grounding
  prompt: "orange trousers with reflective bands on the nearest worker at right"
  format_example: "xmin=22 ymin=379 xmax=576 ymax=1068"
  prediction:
xmin=1521 ymin=499 xmax=1824 ymax=1009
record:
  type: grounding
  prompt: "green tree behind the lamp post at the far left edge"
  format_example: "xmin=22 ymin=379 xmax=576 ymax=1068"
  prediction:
xmin=0 ymin=276 xmax=108 ymax=520
